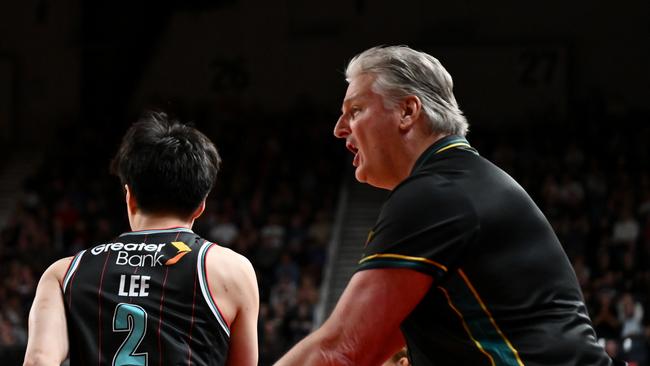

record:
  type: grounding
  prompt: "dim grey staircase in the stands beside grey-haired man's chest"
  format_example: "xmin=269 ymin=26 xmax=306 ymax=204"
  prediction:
xmin=314 ymin=176 xmax=388 ymax=327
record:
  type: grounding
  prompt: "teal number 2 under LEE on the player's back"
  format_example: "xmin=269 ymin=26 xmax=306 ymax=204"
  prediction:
xmin=113 ymin=303 xmax=148 ymax=366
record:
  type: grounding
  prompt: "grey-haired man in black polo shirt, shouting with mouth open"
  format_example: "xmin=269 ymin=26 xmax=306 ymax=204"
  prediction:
xmin=278 ymin=46 xmax=612 ymax=366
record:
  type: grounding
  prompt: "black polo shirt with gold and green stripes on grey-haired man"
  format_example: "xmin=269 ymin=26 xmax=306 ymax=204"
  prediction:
xmin=359 ymin=136 xmax=611 ymax=366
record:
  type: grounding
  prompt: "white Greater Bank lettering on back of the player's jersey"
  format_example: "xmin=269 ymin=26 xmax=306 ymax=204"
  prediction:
xmin=90 ymin=243 xmax=165 ymax=267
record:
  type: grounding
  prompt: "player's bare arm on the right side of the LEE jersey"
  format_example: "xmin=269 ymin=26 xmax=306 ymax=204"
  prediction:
xmin=207 ymin=247 xmax=260 ymax=366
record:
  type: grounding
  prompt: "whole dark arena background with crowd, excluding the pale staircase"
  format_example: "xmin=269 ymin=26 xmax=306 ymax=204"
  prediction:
xmin=0 ymin=0 xmax=650 ymax=365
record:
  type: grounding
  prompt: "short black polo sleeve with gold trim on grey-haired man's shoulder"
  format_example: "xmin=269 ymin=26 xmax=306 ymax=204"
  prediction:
xmin=357 ymin=176 xmax=479 ymax=279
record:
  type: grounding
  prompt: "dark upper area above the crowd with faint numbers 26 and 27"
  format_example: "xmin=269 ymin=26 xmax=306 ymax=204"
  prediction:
xmin=0 ymin=0 xmax=650 ymax=144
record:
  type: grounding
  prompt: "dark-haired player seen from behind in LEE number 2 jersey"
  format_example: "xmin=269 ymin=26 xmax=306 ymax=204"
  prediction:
xmin=25 ymin=113 xmax=259 ymax=366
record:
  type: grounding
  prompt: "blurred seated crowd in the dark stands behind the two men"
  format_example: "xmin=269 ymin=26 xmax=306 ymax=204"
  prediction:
xmin=0 ymin=113 xmax=650 ymax=366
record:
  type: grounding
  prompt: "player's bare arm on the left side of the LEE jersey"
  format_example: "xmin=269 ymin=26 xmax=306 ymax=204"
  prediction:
xmin=24 ymin=257 xmax=72 ymax=366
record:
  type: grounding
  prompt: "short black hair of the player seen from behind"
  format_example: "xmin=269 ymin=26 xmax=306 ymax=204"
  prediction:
xmin=111 ymin=112 xmax=221 ymax=217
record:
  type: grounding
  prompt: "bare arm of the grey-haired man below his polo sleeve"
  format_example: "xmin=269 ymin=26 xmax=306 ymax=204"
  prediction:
xmin=276 ymin=268 xmax=433 ymax=366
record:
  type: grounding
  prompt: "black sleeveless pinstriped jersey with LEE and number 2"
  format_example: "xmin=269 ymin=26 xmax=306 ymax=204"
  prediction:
xmin=63 ymin=228 xmax=230 ymax=366
